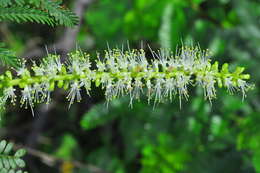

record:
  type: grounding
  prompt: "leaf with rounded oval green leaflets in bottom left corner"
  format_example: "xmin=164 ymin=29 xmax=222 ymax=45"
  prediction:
xmin=0 ymin=140 xmax=26 ymax=173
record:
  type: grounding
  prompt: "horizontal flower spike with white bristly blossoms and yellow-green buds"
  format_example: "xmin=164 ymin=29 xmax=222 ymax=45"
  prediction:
xmin=0 ymin=46 xmax=252 ymax=111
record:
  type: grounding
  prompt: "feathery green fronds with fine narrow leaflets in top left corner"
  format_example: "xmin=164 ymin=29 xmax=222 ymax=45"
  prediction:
xmin=0 ymin=0 xmax=78 ymax=27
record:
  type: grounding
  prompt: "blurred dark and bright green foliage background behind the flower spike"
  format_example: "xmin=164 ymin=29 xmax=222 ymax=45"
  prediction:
xmin=0 ymin=0 xmax=260 ymax=173
